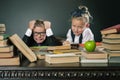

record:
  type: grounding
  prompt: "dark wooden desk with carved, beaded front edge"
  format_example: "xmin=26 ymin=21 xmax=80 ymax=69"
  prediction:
xmin=0 ymin=60 xmax=120 ymax=80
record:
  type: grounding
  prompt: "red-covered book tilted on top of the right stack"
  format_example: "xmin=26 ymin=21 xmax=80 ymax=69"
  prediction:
xmin=101 ymin=24 xmax=120 ymax=34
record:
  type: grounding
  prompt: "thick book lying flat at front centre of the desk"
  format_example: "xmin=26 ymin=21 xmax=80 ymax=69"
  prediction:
xmin=45 ymin=53 xmax=80 ymax=64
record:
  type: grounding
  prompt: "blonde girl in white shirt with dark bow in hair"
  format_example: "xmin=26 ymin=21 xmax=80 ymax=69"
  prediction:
xmin=63 ymin=6 xmax=94 ymax=44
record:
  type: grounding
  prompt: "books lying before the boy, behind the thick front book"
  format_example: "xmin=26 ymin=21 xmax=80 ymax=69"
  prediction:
xmin=30 ymin=45 xmax=81 ymax=59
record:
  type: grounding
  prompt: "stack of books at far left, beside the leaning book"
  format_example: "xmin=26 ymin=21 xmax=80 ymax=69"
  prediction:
xmin=0 ymin=24 xmax=20 ymax=66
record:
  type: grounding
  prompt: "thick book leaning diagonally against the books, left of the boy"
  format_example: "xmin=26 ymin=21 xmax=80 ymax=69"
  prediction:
xmin=9 ymin=34 xmax=37 ymax=62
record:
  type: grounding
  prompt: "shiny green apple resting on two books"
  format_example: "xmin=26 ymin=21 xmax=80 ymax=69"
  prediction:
xmin=84 ymin=40 xmax=96 ymax=52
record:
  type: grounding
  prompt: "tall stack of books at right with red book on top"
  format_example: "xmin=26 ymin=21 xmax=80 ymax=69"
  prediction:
xmin=101 ymin=24 xmax=120 ymax=63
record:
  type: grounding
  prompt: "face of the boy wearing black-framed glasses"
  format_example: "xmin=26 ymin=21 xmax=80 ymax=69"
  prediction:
xmin=33 ymin=27 xmax=46 ymax=43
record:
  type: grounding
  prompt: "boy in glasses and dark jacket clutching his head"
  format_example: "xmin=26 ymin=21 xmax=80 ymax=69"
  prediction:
xmin=23 ymin=20 xmax=62 ymax=47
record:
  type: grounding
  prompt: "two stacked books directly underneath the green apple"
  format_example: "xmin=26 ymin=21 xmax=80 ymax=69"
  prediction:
xmin=81 ymin=51 xmax=108 ymax=64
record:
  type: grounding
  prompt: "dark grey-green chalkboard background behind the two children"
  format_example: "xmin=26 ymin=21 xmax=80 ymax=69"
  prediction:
xmin=0 ymin=0 xmax=120 ymax=41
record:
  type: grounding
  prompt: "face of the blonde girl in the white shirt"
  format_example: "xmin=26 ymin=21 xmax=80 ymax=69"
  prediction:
xmin=71 ymin=18 xmax=86 ymax=36
